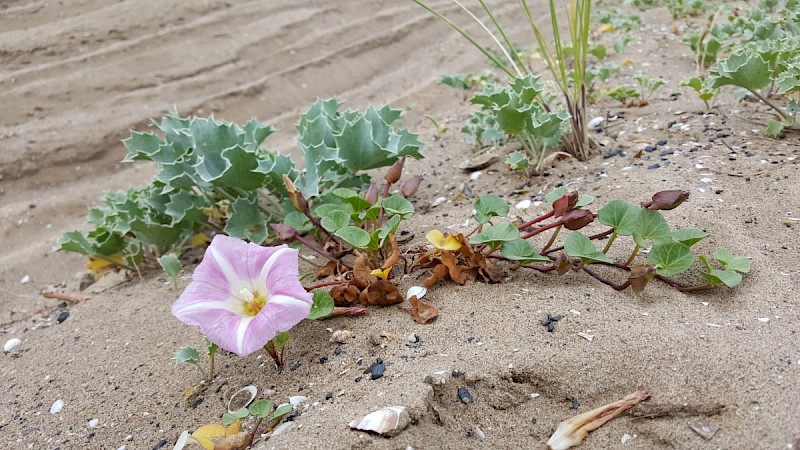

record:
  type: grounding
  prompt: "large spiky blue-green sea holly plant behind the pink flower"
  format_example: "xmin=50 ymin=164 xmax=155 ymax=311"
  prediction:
xmin=56 ymin=100 xmax=422 ymax=272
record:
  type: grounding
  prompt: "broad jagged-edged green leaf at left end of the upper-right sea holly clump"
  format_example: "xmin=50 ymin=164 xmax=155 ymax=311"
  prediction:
xmin=708 ymin=51 xmax=772 ymax=91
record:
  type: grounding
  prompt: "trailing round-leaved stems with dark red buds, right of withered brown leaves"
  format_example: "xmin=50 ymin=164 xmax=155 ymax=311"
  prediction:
xmin=411 ymin=188 xmax=750 ymax=292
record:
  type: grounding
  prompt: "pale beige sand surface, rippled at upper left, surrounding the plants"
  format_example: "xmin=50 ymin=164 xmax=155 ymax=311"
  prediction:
xmin=0 ymin=0 xmax=800 ymax=449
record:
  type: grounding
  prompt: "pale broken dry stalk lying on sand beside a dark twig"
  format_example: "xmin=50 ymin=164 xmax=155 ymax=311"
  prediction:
xmin=547 ymin=391 xmax=650 ymax=450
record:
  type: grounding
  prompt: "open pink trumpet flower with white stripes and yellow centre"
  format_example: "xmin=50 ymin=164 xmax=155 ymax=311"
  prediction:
xmin=172 ymin=235 xmax=312 ymax=356
